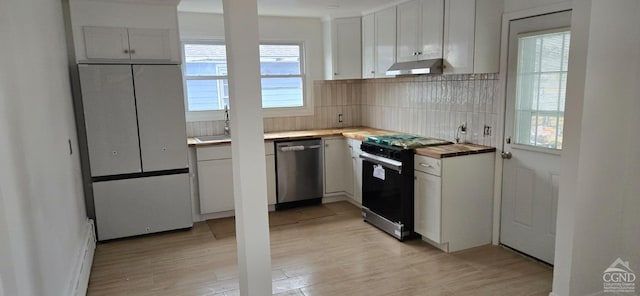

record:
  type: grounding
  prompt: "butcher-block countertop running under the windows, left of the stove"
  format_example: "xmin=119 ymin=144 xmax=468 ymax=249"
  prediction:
xmin=187 ymin=127 xmax=398 ymax=146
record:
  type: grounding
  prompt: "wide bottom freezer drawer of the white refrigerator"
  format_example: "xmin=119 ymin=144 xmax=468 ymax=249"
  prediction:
xmin=93 ymin=174 xmax=193 ymax=240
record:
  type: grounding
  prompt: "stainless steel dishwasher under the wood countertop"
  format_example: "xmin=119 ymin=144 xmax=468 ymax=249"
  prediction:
xmin=275 ymin=139 xmax=322 ymax=210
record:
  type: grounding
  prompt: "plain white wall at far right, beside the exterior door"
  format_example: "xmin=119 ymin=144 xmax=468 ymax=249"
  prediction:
xmin=554 ymin=0 xmax=640 ymax=295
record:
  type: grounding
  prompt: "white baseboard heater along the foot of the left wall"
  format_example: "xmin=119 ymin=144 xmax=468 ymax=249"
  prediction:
xmin=66 ymin=219 xmax=96 ymax=296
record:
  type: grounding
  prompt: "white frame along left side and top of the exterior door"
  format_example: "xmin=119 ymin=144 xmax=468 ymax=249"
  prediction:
xmin=491 ymin=1 xmax=572 ymax=245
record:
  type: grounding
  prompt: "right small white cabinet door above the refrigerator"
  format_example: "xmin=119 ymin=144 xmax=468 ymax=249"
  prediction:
xmin=128 ymin=28 xmax=171 ymax=60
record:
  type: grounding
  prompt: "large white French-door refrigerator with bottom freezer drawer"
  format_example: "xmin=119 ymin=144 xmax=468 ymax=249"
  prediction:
xmin=78 ymin=64 xmax=193 ymax=241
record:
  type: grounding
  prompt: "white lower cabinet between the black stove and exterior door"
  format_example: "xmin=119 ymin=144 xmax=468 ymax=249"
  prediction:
xmin=414 ymin=153 xmax=495 ymax=252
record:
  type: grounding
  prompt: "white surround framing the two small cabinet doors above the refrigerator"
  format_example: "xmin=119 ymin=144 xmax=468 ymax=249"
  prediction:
xmin=69 ymin=0 xmax=181 ymax=62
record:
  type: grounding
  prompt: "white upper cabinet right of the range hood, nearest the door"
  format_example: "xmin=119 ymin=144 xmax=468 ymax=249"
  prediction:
xmin=443 ymin=0 xmax=504 ymax=74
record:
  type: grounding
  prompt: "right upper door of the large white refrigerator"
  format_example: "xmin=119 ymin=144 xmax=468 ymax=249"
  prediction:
xmin=133 ymin=65 xmax=188 ymax=172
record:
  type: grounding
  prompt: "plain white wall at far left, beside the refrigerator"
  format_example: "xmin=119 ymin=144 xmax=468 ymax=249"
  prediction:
xmin=0 ymin=0 xmax=86 ymax=296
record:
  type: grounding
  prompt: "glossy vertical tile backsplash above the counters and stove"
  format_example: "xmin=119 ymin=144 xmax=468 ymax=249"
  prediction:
xmin=187 ymin=74 xmax=500 ymax=146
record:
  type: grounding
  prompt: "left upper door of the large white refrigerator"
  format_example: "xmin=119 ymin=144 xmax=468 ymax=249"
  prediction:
xmin=78 ymin=65 xmax=142 ymax=177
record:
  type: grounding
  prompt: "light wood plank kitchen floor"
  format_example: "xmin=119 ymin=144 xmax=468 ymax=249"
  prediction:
xmin=89 ymin=202 xmax=552 ymax=296
